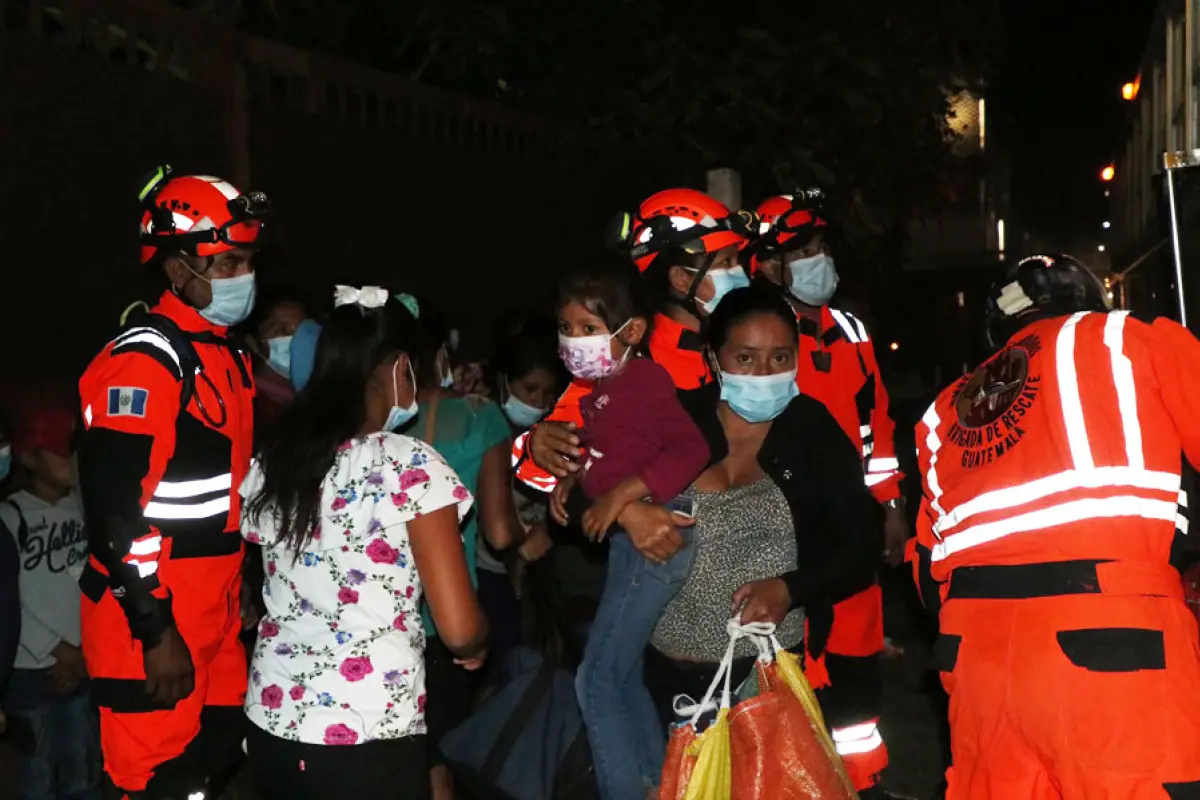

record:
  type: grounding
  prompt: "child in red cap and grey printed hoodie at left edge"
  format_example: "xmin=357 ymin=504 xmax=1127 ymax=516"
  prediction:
xmin=0 ymin=392 xmax=100 ymax=800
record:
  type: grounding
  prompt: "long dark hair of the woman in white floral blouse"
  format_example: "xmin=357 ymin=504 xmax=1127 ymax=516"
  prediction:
xmin=246 ymin=291 xmax=422 ymax=554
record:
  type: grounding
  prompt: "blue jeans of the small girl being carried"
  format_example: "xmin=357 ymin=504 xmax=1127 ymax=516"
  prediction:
xmin=575 ymin=520 xmax=695 ymax=800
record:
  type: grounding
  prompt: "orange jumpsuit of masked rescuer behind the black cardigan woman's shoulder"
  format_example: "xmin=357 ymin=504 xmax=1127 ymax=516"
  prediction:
xmin=796 ymin=306 xmax=904 ymax=789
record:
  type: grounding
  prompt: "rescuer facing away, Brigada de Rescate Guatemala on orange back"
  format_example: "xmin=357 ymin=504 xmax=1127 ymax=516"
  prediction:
xmin=917 ymin=255 xmax=1200 ymax=800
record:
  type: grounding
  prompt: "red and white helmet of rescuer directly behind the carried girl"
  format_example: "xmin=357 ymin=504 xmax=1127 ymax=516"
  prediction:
xmin=614 ymin=188 xmax=756 ymax=272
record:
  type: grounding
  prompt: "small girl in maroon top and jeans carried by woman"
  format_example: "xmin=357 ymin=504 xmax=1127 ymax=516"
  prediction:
xmin=551 ymin=261 xmax=709 ymax=800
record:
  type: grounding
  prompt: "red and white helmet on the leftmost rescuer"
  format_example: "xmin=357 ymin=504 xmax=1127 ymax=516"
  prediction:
xmin=138 ymin=167 xmax=270 ymax=264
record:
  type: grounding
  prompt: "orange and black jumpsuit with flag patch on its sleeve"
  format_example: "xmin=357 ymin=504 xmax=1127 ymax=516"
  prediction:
xmin=79 ymin=291 xmax=254 ymax=796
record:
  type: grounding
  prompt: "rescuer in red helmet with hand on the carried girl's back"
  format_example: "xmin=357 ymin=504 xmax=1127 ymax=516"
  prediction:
xmin=512 ymin=188 xmax=754 ymax=492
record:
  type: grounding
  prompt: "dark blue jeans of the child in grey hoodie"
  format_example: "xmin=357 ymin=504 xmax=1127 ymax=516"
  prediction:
xmin=5 ymin=669 xmax=101 ymax=800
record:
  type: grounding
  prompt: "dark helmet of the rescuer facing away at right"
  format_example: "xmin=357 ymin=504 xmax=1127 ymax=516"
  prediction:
xmin=984 ymin=254 xmax=1111 ymax=348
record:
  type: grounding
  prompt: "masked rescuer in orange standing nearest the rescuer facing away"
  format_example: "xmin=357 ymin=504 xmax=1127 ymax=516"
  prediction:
xmin=748 ymin=190 xmax=908 ymax=796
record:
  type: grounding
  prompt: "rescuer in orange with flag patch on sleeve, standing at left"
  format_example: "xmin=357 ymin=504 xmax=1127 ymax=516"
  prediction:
xmin=79 ymin=167 xmax=268 ymax=800
